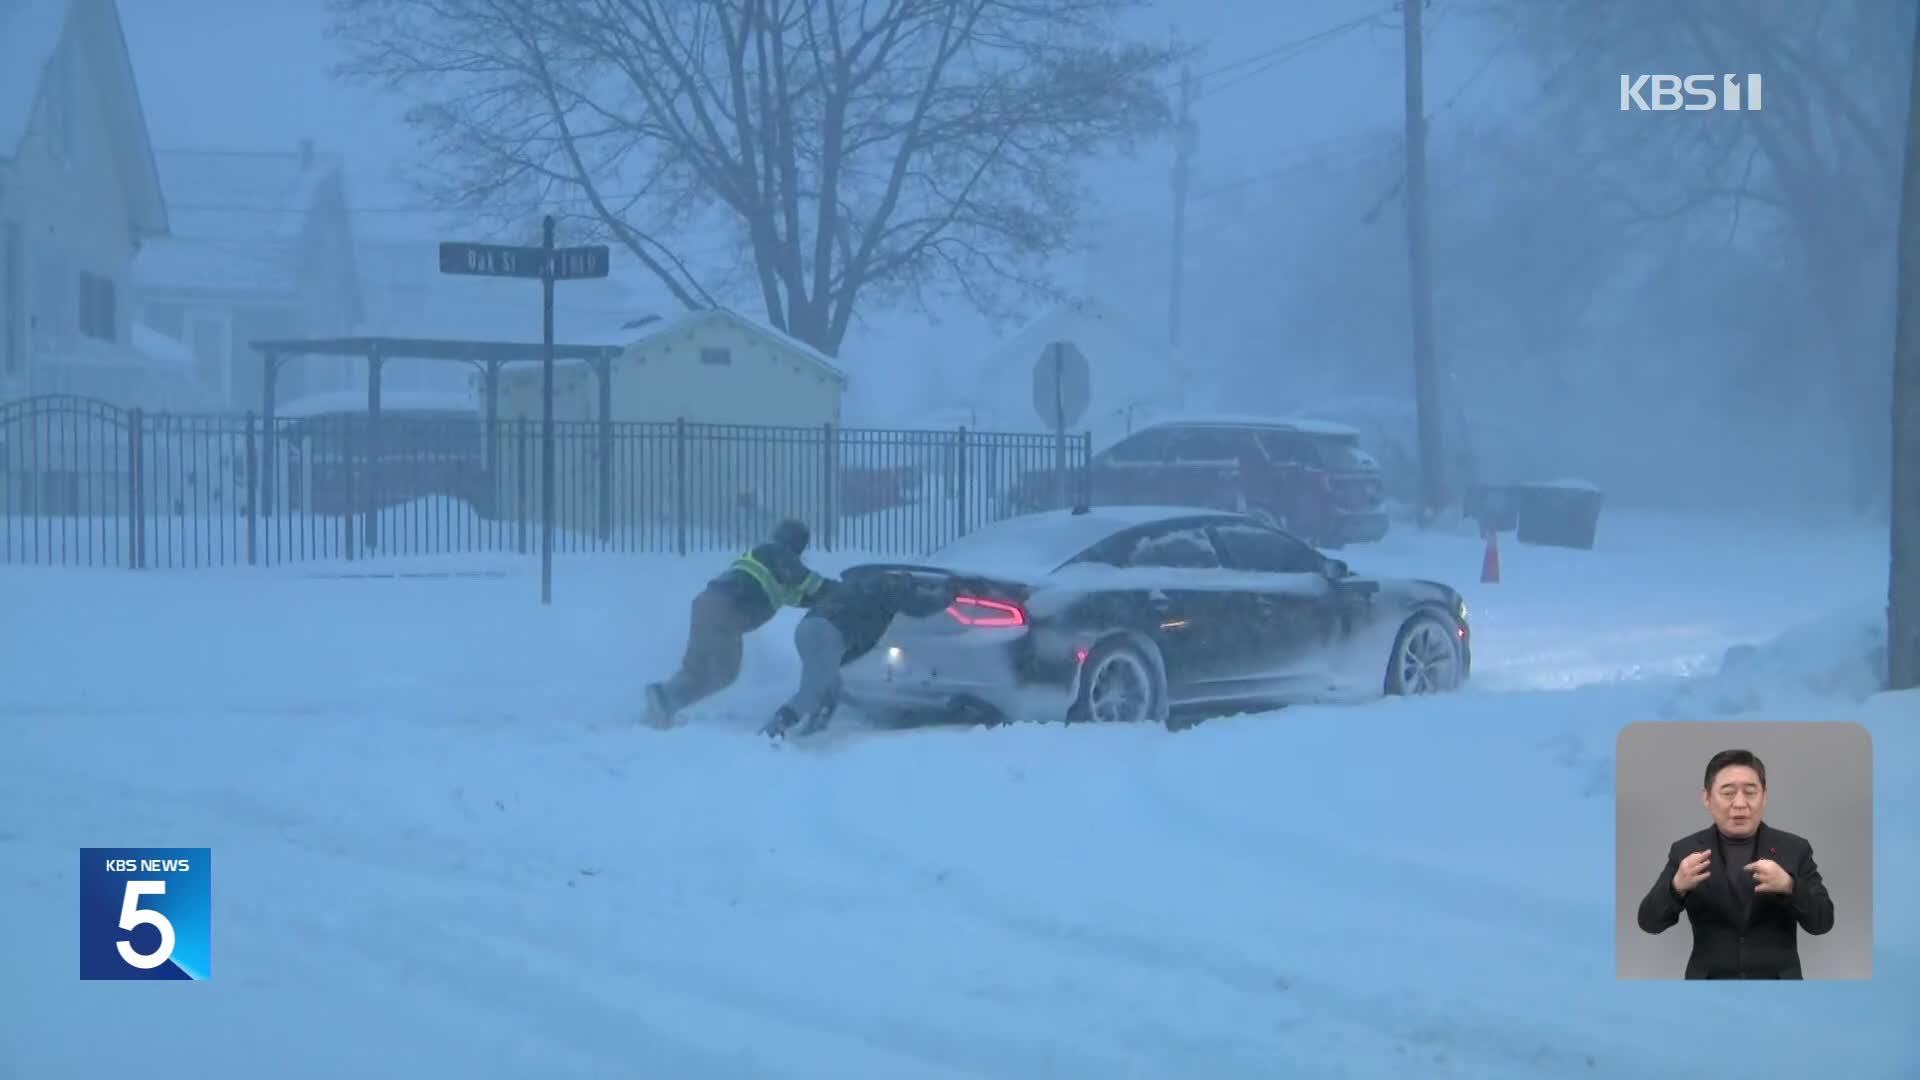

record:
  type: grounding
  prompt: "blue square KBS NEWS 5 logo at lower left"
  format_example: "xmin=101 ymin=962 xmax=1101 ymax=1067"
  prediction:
xmin=81 ymin=847 xmax=213 ymax=980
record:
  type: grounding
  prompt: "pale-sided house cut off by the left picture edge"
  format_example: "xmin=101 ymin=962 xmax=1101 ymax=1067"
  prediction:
xmin=0 ymin=0 xmax=188 ymax=407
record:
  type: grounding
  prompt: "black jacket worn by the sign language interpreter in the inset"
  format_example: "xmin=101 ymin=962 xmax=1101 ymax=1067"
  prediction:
xmin=1640 ymin=822 xmax=1834 ymax=978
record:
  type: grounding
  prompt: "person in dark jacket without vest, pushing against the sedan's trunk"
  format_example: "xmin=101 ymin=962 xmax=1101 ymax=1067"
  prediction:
xmin=760 ymin=571 xmax=958 ymax=738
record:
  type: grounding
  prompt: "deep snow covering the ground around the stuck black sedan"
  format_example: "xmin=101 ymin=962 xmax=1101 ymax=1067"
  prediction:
xmin=0 ymin=513 xmax=1920 ymax=1078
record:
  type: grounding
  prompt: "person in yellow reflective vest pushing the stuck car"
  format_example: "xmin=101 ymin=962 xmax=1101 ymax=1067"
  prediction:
xmin=647 ymin=517 xmax=826 ymax=728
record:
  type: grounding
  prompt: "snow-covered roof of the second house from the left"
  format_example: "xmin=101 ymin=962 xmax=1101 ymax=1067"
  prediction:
xmin=134 ymin=150 xmax=340 ymax=292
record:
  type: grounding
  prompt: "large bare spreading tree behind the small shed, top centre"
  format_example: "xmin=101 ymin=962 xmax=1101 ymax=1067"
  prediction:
xmin=328 ymin=0 xmax=1177 ymax=354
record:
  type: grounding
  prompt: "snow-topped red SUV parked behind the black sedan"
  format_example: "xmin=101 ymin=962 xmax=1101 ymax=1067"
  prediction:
xmin=1020 ymin=419 xmax=1386 ymax=548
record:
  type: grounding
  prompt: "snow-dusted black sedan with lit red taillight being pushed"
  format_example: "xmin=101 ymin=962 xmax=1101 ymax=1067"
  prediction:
xmin=843 ymin=505 xmax=1473 ymax=724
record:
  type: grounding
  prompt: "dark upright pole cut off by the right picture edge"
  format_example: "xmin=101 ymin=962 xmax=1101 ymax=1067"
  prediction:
xmin=1887 ymin=8 xmax=1920 ymax=690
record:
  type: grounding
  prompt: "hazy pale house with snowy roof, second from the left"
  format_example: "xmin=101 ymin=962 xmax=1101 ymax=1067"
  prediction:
xmin=134 ymin=140 xmax=363 ymax=411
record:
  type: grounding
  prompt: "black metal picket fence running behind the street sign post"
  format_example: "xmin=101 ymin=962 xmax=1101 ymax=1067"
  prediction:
xmin=0 ymin=396 xmax=1091 ymax=569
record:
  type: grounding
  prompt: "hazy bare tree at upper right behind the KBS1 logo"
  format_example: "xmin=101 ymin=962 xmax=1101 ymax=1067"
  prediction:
xmin=1480 ymin=0 xmax=1912 ymax=505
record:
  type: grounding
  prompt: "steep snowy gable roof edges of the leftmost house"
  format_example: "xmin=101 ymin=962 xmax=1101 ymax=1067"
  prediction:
xmin=0 ymin=0 xmax=167 ymax=236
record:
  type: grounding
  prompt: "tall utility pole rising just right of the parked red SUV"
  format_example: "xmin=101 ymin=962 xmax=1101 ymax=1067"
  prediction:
xmin=1400 ymin=0 xmax=1446 ymax=523
